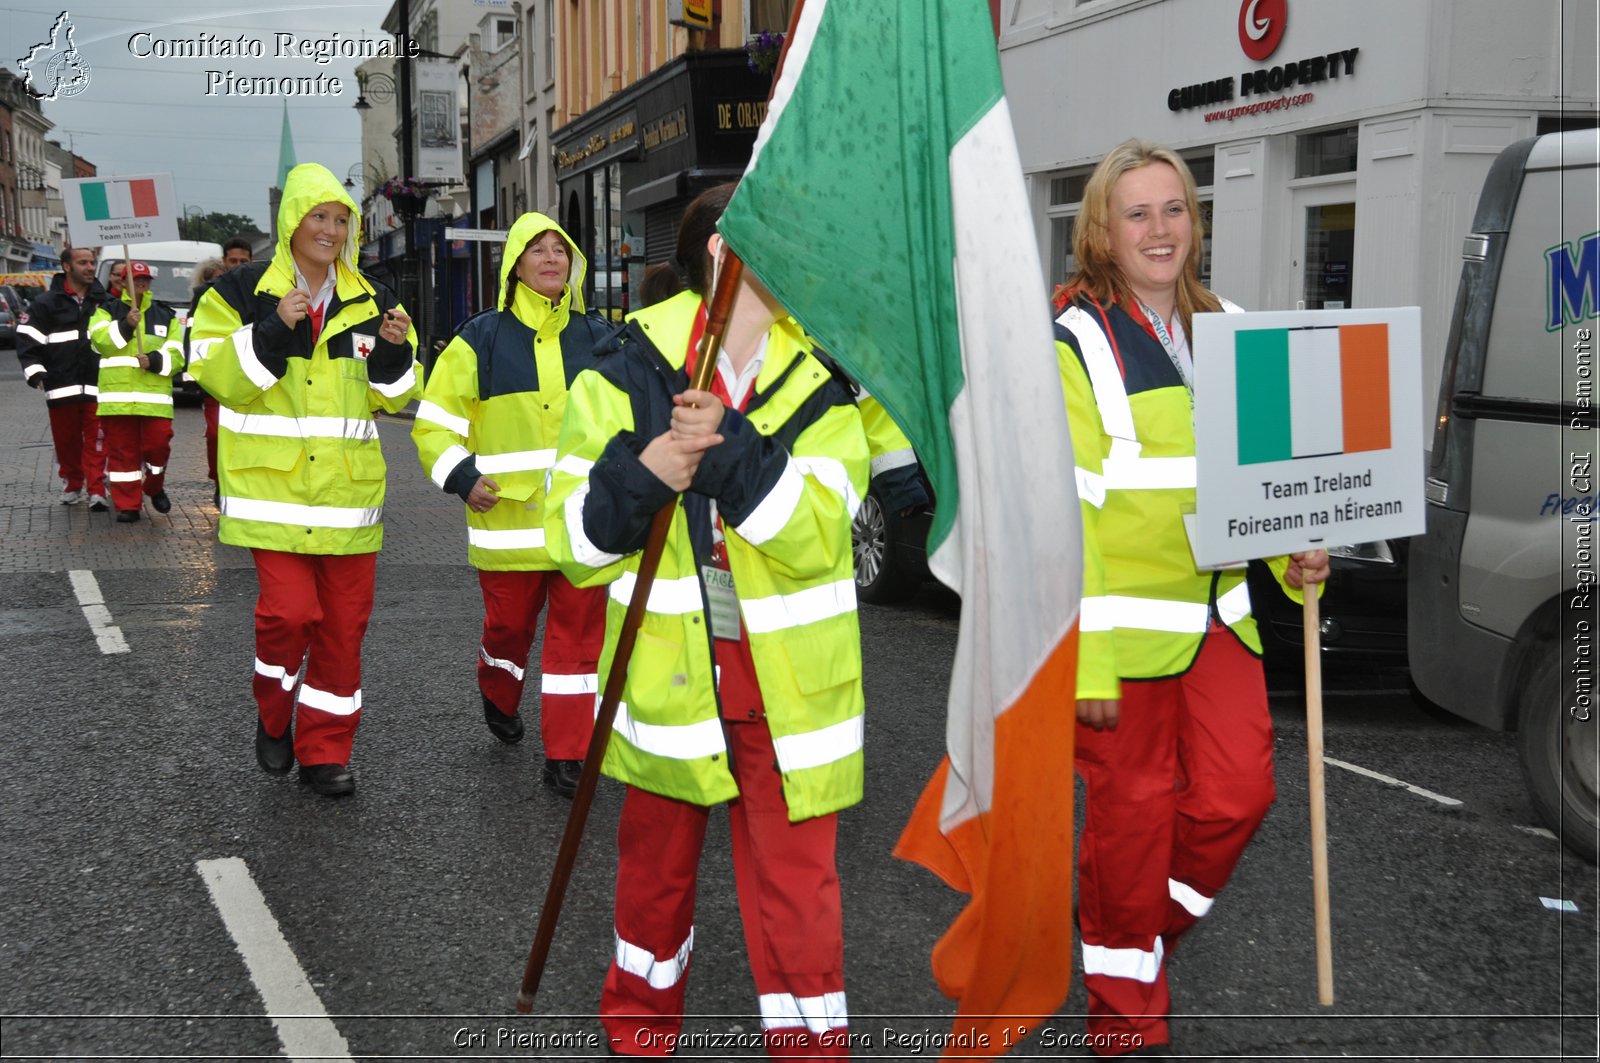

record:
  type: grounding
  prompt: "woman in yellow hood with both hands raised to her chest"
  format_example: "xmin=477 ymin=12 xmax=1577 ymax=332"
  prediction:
xmin=190 ymin=163 xmax=419 ymax=797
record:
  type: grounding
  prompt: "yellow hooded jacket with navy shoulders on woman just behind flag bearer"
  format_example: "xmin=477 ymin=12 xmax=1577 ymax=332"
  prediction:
xmin=411 ymin=213 xmax=611 ymax=572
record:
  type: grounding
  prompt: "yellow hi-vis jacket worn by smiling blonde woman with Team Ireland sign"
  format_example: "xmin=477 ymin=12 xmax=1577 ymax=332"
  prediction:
xmin=1056 ymin=295 xmax=1320 ymax=700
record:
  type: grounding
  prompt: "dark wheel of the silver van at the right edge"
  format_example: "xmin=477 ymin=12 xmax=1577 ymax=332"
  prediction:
xmin=1517 ymin=642 xmax=1600 ymax=863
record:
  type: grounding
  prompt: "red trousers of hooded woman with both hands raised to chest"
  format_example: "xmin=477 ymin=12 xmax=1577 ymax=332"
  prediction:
xmin=251 ymin=549 xmax=378 ymax=764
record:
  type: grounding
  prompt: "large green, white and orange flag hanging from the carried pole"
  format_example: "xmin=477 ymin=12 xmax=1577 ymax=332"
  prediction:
xmin=722 ymin=0 xmax=1082 ymax=1057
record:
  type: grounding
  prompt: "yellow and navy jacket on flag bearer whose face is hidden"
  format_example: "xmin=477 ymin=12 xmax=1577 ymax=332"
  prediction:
xmin=544 ymin=291 xmax=867 ymax=821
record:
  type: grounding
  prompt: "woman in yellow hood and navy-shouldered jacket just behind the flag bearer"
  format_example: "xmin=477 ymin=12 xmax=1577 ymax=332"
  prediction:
xmin=411 ymin=213 xmax=610 ymax=797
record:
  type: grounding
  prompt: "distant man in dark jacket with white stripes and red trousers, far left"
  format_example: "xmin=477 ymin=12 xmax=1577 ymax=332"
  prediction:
xmin=16 ymin=247 xmax=110 ymax=512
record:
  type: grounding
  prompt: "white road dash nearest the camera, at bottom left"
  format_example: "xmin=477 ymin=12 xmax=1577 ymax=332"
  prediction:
xmin=195 ymin=856 xmax=350 ymax=1060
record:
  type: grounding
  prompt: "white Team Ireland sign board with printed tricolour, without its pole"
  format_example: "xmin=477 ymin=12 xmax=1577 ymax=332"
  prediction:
xmin=1194 ymin=306 xmax=1424 ymax=565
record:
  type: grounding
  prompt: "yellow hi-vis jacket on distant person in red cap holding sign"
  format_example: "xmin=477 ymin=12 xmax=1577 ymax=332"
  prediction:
xmin=90 ymin=288 xmax=184 ymax=418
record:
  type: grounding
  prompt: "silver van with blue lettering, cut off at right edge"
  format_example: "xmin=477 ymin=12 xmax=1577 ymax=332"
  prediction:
xmin=1406 ymin=130 xmax=1600 ymax=861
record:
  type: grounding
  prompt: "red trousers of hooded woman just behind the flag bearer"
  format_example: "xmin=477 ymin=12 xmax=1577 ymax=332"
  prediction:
xmin=478 ymin=570 xmax=606 ymax=760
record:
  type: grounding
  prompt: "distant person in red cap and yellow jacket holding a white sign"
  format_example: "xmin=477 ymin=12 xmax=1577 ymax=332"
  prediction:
xmin=90 ymin=263 xmax=184 ymax=523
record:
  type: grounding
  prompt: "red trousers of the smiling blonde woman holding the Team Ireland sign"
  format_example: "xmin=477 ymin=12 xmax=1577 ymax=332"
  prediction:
xmin=1077 ymin=621 xmax=1275 ymax=1055
